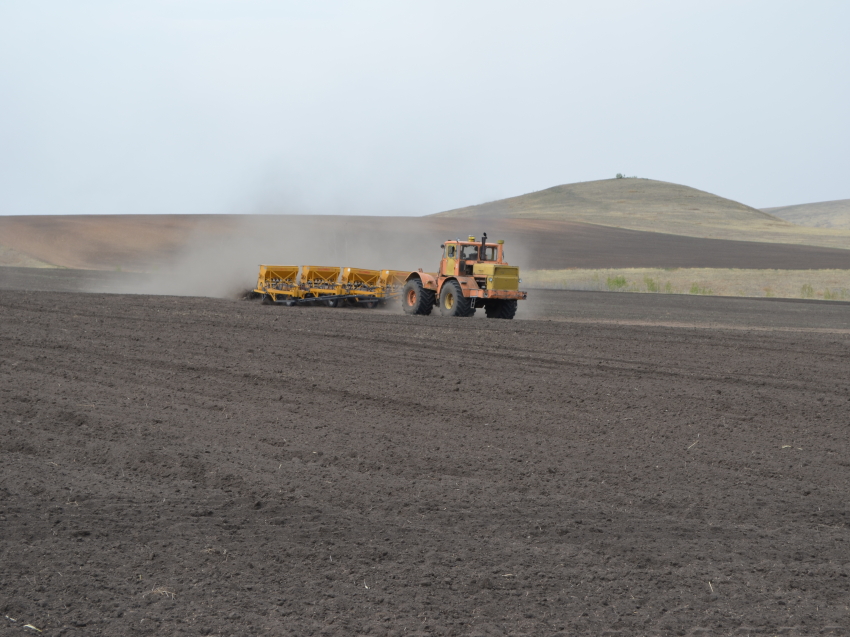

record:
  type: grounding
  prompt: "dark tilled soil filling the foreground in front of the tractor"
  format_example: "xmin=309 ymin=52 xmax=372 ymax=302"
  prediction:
xmin=0 ymin=274 xmax=850 ymax=635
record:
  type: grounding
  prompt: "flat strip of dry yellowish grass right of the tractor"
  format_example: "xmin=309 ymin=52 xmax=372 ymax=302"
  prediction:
xmin=523 ymin=268 xmax=850 ymax=301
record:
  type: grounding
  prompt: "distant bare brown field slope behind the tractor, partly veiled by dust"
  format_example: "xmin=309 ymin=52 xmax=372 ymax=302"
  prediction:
xmin=0 ymin=214 xmax=850 ymax=278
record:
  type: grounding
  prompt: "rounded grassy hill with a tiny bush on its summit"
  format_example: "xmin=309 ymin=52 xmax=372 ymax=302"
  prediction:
xmin=434 ymin=178 xmax=850 ymax=249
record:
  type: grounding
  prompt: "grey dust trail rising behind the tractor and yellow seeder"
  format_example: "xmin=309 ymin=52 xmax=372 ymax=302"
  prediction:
xmin=101 ymin=215 xmax=536 ymax=298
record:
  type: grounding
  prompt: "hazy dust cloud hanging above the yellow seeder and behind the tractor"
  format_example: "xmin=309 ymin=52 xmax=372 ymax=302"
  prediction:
xmin=64 ymin=215 xmax=533 ymax=298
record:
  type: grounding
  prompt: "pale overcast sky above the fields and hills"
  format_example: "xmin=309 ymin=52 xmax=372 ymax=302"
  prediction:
xmin=0 ymin=0 xmax=850 ymax=215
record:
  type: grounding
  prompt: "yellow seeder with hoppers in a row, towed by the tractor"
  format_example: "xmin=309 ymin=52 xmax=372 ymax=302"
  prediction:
xmin=253 ymin=265 xmax=409 ymax=308
